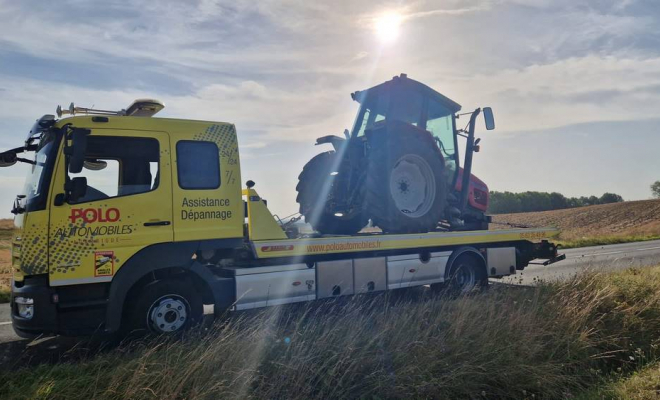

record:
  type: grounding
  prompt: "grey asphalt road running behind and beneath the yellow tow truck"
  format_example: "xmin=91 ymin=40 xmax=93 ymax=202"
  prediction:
xmin=0 ymin=240 xmax=660 ymax=368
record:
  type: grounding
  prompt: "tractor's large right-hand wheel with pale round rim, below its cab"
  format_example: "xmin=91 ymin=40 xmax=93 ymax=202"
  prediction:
xmin=365 ymin=133 xmax=447 ymax=233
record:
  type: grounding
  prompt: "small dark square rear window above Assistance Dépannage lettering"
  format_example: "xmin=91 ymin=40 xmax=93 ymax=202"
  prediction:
xmin=176 ymin=140 xmax=220 ymax=190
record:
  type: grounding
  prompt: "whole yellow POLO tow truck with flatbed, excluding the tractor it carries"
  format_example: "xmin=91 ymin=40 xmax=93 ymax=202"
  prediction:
xmin=0 ymin=100 xmax=561 ymax=337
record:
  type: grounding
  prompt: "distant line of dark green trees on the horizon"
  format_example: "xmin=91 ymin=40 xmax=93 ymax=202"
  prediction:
xmin=488 ymin=192 xmax=623 ymax=214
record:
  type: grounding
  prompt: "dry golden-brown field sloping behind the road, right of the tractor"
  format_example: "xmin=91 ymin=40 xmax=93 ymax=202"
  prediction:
xmin=491 ymin=200 xmax=660 ymax=243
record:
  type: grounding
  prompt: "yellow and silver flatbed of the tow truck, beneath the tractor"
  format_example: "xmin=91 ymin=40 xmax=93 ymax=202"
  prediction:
xmin=219 ymin=189 xmax=563 ymax=310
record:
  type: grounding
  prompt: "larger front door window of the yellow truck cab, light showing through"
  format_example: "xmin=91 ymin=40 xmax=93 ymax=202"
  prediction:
xmin=69 ymin=136 xmax=160 ymax=203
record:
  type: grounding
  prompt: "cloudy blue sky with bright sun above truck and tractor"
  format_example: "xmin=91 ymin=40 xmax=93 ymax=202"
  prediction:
xmin=0 ymin=0 xmax=660 ymax=217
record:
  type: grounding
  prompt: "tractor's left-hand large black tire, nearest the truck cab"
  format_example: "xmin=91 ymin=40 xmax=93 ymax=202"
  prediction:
xmin=296 ymin=151 xmax=367 ymax=235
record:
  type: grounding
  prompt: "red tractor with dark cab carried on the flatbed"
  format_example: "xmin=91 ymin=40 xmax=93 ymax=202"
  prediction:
xmin=296 ymin=74 xmax=494 ymax=235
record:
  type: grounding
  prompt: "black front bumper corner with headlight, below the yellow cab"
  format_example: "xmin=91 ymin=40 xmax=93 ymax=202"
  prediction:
xmin=10 ymin=275 xmax=58 ymax=338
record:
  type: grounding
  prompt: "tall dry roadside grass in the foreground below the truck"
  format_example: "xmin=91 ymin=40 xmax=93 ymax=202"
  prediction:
xmin=0 ymin=269 xmax=660 ymax=399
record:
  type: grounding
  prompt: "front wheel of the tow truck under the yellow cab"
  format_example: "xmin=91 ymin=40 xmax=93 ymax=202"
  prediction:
xmin=124 ymin=279 xmax=204 ymax=335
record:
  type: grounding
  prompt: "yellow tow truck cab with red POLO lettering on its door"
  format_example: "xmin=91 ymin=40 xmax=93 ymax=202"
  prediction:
xmin=7 ymin=101 xmax=244 ymax=332
